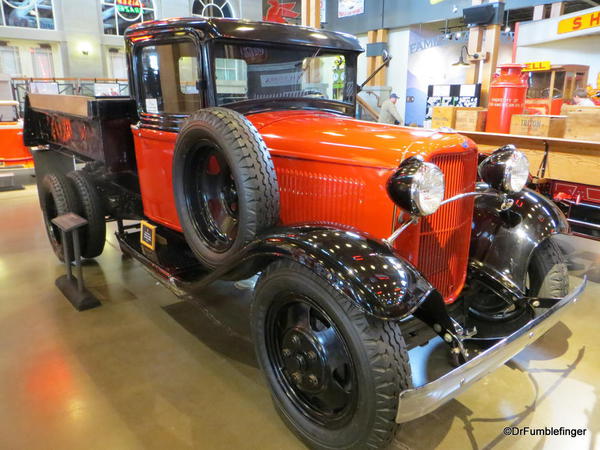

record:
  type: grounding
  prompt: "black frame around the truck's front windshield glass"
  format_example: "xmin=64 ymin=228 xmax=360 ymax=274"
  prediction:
xmin=206 ymin=38 xmax=360 ymax=117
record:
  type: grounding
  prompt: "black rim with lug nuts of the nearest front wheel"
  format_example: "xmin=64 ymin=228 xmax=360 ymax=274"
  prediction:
xmin=266 ymin=293 xmax=358 ymax=428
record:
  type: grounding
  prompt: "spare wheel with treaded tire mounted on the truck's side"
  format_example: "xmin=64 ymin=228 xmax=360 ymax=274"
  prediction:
xmin=173 ymin=108 xmax=279 ymax=269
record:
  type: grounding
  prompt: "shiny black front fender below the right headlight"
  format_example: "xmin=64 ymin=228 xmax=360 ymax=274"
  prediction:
xmin=469 ymin=188 xmax=569 ymax=298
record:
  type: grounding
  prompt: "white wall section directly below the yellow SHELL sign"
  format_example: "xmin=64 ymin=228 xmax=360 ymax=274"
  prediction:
xmin=517 ymin=34 xmax=600 ymax=86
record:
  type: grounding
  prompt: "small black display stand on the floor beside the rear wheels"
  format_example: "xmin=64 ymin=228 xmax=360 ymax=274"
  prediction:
xmin=52 ymin=213 xmax=101 ymax=311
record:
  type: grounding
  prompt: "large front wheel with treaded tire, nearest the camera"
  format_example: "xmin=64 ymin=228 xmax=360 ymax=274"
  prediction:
xmin=251 ymin=261 xmax=412 ymax=449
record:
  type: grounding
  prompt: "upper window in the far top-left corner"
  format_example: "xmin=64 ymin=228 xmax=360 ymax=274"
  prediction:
xmin=0 ymin=0 xmax=54 ymax=30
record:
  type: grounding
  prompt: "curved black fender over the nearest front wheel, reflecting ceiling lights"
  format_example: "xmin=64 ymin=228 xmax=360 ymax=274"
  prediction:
xmin=212 ymin=226 xmax=435 ymax=319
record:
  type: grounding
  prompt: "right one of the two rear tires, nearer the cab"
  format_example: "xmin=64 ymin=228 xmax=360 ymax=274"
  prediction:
xmin=67 ymin=170 xmax=106 ymax=258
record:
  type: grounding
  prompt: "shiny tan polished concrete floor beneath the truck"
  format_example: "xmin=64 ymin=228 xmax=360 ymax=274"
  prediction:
xmin=0 ymin=187 xmax=600 ymax=450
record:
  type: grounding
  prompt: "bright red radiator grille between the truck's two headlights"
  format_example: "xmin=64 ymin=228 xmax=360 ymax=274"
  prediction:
xmin=417 ymin=150 xmax=477 ymax=302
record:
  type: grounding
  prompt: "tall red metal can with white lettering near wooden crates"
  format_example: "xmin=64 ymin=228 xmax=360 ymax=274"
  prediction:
xmin=485 ymin=64 xmax=529 ymax=133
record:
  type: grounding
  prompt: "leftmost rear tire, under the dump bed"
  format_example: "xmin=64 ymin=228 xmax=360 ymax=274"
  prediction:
xmin=39 ymin=173 xmax=81 ymax=261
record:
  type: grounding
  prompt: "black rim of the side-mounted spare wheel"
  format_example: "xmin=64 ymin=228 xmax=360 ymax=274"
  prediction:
xmin=186 ymin=142 xmax=239 ymax=252
